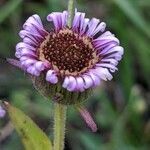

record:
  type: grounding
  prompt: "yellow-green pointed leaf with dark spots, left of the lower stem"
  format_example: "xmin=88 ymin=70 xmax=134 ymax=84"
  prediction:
xmin=4 ymin=102 xmax=52 ymax=150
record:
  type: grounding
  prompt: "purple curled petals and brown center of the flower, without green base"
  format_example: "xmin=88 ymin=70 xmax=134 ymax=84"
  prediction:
xmin=9 ymin=11 xmax=123 ymax=104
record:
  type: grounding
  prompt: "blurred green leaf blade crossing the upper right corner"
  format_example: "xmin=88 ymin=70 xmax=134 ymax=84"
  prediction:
xmin=114 ymin=0 xmax=150 ymax=37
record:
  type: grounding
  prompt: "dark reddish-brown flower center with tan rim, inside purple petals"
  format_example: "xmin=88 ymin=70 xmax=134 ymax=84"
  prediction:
xmin=38 ymin=28 xmax=99 ymax=76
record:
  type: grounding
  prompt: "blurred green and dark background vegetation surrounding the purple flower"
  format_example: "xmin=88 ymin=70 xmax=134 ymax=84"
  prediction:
xmin=0 ymin=0 xmax=150 ymax=150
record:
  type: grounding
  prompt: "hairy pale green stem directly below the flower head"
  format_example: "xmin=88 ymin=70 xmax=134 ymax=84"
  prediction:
xmin=54 ymin=103 xmax=67 ymax=150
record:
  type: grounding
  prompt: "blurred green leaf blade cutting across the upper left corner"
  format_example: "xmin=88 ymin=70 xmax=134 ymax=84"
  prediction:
xmin=0 ymin=0 xmax=22 ymax=23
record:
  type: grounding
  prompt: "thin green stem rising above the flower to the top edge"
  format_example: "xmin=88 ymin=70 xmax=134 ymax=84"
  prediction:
xmin=67 ymin=0 xmax=75 ymax=28
